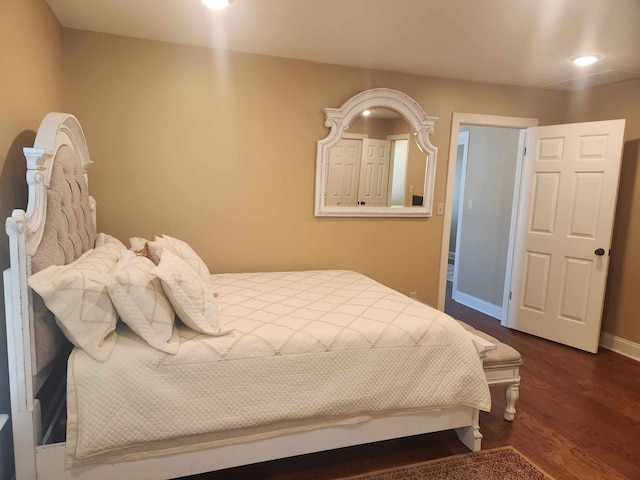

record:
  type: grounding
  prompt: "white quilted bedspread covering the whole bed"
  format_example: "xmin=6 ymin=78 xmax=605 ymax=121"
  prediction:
xmin=67 ymin=271 xmax=490 ymax=465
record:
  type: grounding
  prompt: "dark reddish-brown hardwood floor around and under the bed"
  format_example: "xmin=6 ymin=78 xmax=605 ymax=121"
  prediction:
xmin=180 ymin=284 xmax=640 ymax=480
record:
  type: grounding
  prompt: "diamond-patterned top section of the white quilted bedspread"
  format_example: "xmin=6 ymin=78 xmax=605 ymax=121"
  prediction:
xmin=190 ymin=271 xmax=448 ymax=360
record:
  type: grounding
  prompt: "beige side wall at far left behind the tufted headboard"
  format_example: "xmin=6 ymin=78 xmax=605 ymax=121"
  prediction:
xmin=0 ymin=0 xmax=65 ymax=479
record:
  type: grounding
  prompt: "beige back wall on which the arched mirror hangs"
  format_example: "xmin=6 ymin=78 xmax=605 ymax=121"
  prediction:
xmin=65 ymin=30 xmax=568 ymax=312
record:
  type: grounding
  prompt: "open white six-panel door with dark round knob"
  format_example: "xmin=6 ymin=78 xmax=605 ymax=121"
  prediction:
xmin=507 ymin=120 xmax=624 ymax=353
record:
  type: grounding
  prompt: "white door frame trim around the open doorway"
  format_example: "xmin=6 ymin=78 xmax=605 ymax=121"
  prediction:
xmin=437 ymin=112 xmax=538 ymax=325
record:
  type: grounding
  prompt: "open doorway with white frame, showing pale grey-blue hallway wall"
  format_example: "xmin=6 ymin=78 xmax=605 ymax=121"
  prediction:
xmin=438 ymin=113 xmax=538 ymax=325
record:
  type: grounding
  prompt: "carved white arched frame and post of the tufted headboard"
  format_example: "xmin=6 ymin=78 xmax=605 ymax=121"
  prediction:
xmin=3 ymin=112 xmax=95 ymax=479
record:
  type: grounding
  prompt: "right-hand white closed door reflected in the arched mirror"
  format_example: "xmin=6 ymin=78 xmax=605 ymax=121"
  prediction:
xmin=358 ymin=139 xmax=391 ymax=207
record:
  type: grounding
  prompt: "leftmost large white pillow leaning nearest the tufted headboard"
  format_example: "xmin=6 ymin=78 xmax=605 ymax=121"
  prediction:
xmin=28 ymin=242 xmax=124 ymax=362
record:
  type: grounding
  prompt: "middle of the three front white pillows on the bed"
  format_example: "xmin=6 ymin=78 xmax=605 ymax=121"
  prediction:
xmin=96 ymin=250 xmax=180 ymax=355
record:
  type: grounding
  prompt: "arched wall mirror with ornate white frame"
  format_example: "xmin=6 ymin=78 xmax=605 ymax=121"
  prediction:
xmin=315 ymin=88 xmax=437 ymax=217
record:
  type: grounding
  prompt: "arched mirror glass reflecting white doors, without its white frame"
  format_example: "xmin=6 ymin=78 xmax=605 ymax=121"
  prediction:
xmin=324 ymin=107 xmax=427 ymax=208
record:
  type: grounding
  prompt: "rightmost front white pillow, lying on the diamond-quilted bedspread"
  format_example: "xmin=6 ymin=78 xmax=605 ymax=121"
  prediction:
xmin=150 ymin=249 xmax=228 ymax=335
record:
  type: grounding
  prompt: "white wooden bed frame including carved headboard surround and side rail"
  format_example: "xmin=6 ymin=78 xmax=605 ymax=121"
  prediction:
xmin=4 ymin=113 xmax=495 ymax=480
